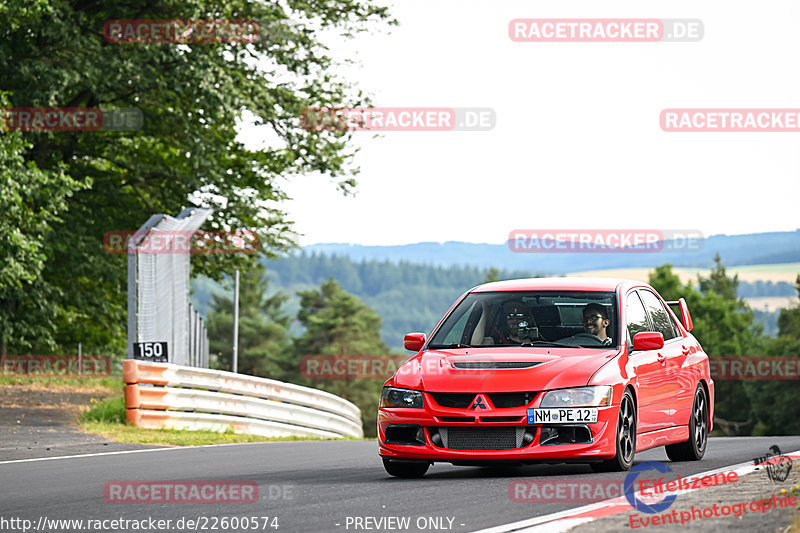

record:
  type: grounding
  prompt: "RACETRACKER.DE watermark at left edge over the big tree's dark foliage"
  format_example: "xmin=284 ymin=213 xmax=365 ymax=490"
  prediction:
xmin=0 ymin=107 xmax=144 ymax=131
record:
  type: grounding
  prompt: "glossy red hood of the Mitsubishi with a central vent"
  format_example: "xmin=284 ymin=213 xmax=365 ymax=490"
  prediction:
xmin=393 ymin=347 xmax=620 ymax=392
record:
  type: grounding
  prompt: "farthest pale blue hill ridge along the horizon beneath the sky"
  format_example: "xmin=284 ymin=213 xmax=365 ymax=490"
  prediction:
xmin=305 ymin=229 xmax=800 ymax=274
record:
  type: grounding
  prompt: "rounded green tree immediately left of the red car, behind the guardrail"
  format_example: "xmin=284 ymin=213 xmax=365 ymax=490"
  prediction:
xmin=295 ymin=278 xmax=389 ymax=437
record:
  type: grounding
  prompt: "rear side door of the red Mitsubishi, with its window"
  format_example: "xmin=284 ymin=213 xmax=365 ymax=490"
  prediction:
xmin=639 ymin=289 xmax=694 ymax=426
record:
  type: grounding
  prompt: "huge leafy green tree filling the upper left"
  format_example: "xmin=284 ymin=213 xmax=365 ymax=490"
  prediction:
xmin=0 ymin=0 xmax=392 ymax=350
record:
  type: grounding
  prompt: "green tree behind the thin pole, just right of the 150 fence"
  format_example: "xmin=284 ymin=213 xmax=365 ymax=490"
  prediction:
xmin=208 ymin=265 xmax=298 ymax=381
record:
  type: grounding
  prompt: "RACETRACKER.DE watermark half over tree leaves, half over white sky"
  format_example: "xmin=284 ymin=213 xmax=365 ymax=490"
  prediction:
xmin=300 ymin=107 xmax=497 ymax=131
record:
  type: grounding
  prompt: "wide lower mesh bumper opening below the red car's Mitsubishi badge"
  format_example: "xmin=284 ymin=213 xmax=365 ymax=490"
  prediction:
xmin=429 ymin=426 xmax=536 ymax=450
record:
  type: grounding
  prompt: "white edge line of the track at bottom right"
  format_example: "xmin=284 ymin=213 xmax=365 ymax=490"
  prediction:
xmin=474 ymin=450 xmax=800 ymax=533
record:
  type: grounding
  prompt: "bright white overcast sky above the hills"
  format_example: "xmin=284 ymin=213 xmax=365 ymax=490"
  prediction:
xmin=244 ymin=0 xmax=800 ymax=245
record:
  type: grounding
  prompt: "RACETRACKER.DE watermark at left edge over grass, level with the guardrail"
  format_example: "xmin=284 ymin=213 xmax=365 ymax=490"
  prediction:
xmin=0 ymin=355 xmax=111 ymax=378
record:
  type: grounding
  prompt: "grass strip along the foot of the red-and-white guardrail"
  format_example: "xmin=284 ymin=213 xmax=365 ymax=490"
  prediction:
xmin=79 ymin=396 xmax=364 ymax=446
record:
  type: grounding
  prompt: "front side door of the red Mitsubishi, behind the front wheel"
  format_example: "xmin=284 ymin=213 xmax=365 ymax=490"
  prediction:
xmin=625 ymin=290 xmax=674 ymax=433
